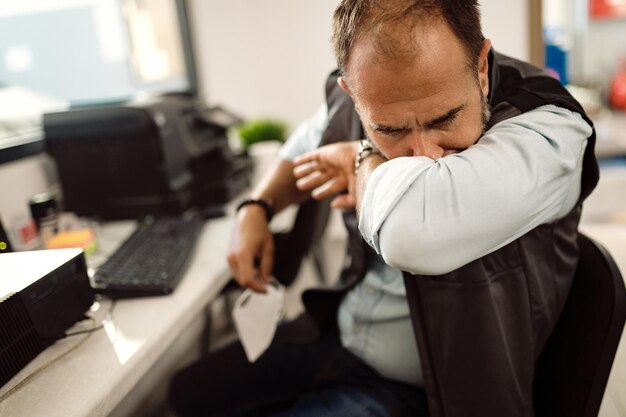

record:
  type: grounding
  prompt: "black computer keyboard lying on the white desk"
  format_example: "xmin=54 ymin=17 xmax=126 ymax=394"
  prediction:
xmin=91 ymin=216 xmax=204 ymax=298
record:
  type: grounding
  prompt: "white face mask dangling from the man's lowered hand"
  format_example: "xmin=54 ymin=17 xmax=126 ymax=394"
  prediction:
xmin=233 ymin=279 xmax=285 ymax=362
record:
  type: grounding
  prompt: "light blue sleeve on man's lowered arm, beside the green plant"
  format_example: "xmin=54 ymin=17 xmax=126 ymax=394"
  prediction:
xmin=278 ymin=104 xmax=328 ymax=161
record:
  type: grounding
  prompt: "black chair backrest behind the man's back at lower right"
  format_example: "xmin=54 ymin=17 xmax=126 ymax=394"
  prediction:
xmin=534 ymin=234 xmax=626 ymax=417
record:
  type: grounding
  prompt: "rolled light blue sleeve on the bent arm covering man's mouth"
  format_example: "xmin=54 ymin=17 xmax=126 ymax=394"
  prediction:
xmin=359 ymin=105 xmax=592 ymax=275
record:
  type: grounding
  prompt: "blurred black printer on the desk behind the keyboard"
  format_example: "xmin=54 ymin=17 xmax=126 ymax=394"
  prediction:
xmin=43 ymin=94 xmax=252 ymax=219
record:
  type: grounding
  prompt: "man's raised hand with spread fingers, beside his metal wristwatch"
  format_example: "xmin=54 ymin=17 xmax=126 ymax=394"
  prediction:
xmin=293 ymin=141 xmax=358 ymax=209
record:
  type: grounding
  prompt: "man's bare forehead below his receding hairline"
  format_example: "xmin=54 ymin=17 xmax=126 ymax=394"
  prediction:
xmin=346 ymin=20 xmax=475 ymax=111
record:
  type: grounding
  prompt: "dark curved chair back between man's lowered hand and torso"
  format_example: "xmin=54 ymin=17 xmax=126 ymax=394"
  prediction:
xmin=273 ymin=199 xmax=330 ymax=286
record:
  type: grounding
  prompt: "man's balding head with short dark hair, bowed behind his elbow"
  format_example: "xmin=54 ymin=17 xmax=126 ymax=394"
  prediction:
xmin=335 ymin=0 xmax=491 ymax=159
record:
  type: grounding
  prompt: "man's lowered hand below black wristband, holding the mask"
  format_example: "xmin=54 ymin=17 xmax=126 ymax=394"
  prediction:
xmin=228 ymin=204 xmax=274 ymax=293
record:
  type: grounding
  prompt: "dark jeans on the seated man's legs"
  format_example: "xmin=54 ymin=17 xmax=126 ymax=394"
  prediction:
xmin=169 ymin=324 xmax=428 ymax=417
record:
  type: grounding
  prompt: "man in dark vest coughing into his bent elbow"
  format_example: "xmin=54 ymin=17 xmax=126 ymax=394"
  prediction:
xmin=171 ymin=0 xmax=597 ymax=417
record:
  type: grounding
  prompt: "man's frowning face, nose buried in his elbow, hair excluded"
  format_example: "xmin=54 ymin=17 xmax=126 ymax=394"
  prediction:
xmin=340 ymin=17 xmax=490 ymax=159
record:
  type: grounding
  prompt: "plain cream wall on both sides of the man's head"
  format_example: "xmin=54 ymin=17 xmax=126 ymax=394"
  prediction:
xmin=186 ymin=0 xmax=528 ymax=131
